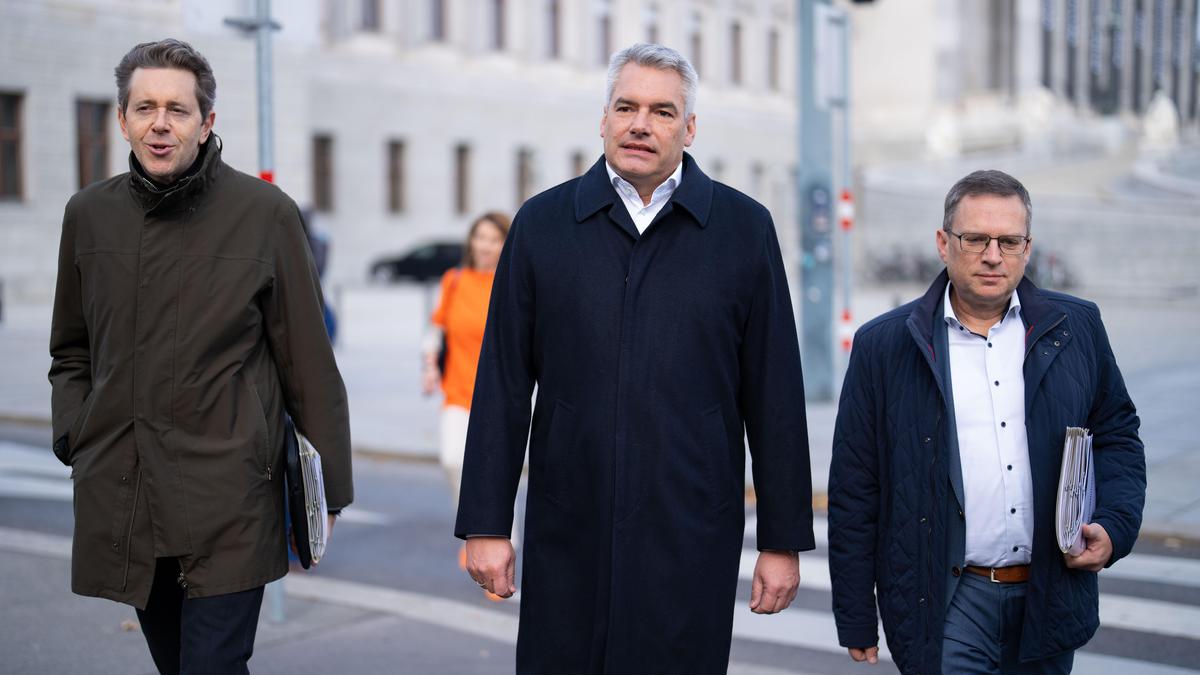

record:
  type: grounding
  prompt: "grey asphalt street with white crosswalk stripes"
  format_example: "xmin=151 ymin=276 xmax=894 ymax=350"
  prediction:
xmin=0 ymin=425 xmax=1200 ymax=675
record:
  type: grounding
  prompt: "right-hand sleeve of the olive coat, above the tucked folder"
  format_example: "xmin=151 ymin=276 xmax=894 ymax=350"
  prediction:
xmin=262 ymin=199 xmax=354 ymax=510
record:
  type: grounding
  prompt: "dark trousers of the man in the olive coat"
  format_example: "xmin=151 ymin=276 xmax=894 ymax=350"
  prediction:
xmin=138 ymin=557 xmax=263 ymax=675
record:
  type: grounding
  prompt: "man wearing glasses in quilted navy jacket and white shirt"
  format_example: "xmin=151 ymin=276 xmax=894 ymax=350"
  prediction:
xmin=829 ymin=171 xmax=1146 ymax=673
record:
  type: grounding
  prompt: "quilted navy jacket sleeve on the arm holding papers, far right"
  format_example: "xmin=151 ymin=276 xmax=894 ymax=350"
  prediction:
xmin=1087 ymin=307 xmax=1146 ymax=566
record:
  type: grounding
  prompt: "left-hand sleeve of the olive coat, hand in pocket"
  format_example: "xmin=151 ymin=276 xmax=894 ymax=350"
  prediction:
xmin=49 ymin=196 xmax=91 ymax=464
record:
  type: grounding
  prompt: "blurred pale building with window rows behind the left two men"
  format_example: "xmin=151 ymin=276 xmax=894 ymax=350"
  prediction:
xmin=0 ymin=0 xmax=796 ymax=294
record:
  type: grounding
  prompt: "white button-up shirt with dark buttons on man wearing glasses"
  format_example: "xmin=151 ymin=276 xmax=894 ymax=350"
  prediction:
xmin=944 ymin=285 xmax=1033 ymax=567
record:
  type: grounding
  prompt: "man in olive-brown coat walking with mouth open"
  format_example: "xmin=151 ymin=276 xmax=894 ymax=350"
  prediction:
xmin=49 ymin=40 xmax=353 ymax=673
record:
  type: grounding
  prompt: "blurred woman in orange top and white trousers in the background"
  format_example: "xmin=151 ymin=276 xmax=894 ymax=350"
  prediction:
xmin=421 ymin=211 xmax=517 ymax=588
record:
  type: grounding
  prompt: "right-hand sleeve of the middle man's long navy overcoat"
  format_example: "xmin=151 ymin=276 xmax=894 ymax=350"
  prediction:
xmin=738 ymin=215 xmax=815 ymax=551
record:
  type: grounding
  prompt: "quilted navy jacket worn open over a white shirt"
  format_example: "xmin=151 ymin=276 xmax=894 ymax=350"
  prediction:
xmin=829 ymin=271 xmax=1146 ymax=673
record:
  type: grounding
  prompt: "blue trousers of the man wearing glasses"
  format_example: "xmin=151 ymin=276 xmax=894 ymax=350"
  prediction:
xmin=942 ymin=573 xmax=1075 ymax=675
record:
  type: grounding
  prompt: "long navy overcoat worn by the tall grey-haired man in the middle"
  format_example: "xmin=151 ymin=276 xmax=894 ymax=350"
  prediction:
xmin=455 ymin=155 xmax=814 ymax=675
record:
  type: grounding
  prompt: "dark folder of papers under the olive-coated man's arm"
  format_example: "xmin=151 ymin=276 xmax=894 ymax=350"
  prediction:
xmin=283 ymin=417 xmax=329 ymax=569
